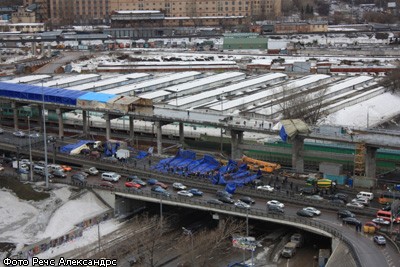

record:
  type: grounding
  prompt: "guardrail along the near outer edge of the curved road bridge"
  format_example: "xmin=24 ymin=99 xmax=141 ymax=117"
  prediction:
xmin=59 ymin=181 xmax=361 ymax=267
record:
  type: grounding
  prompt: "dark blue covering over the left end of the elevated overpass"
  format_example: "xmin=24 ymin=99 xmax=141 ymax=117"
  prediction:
xmin=0 ymin=82 xmax=86 ymax=106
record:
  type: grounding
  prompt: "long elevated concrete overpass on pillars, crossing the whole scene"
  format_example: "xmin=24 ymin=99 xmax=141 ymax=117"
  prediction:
xmin=0 ymin=83 xmax=400 ymax=179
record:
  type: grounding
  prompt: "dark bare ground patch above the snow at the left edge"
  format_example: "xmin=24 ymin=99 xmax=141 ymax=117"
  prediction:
xmin=0 ymin=176 xmax=50 ymax=201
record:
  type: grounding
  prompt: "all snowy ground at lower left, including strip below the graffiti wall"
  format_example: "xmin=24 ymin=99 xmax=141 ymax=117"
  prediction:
xmin=0 ymin=184 xmax=112 ymax=258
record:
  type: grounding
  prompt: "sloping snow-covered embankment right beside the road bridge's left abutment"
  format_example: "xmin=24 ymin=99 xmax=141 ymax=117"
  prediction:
xmin=38 ymin=192 xmax=108 ymax=239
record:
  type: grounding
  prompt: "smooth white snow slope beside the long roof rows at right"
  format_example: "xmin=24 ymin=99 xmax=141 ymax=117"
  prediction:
xmin=320 ymin=92 xmax=400 ymax=127
